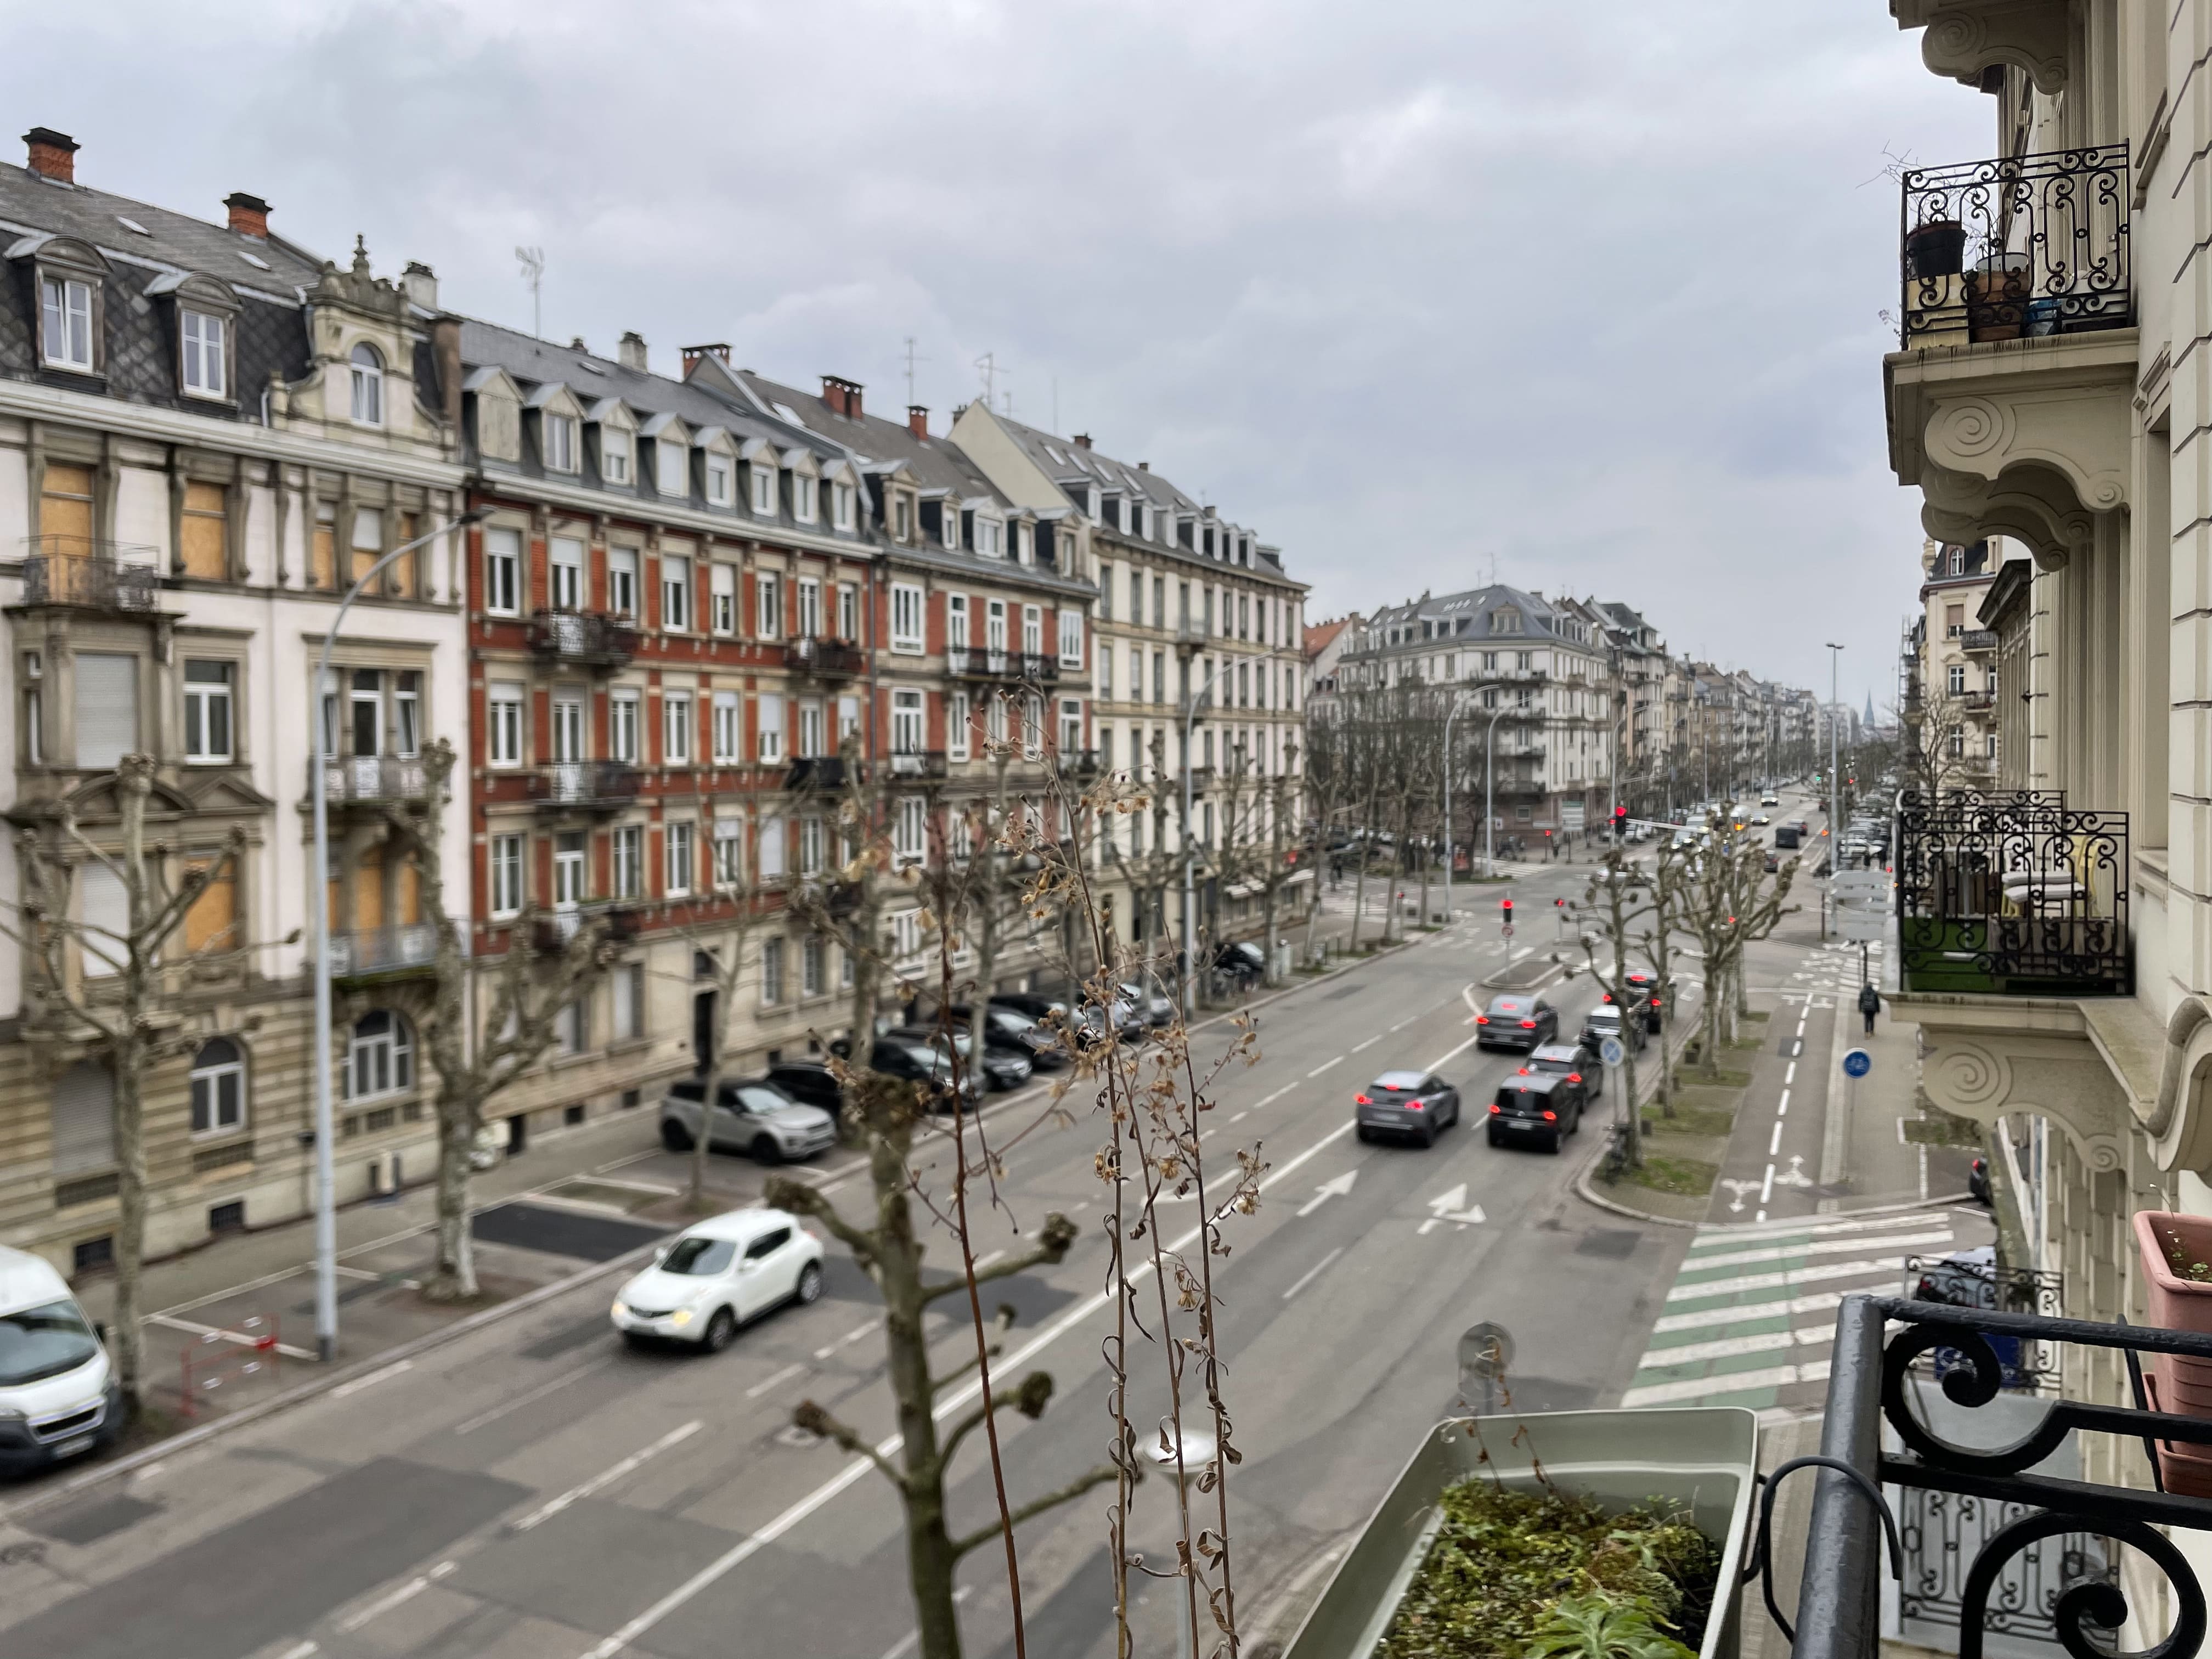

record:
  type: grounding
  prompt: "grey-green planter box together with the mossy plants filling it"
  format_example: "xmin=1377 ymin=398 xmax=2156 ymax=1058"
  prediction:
xmin=1283 ymin=1407 xmax=1758 ymax=1659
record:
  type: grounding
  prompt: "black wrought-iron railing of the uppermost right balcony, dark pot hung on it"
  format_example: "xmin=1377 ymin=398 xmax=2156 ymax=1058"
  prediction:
xmin=1898 ymin=144 xmax=2135 ymax=352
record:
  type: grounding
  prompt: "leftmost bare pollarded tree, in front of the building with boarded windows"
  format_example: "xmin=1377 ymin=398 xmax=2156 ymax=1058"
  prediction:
xmin=0 ymin=754 xmax=246 ymax=1411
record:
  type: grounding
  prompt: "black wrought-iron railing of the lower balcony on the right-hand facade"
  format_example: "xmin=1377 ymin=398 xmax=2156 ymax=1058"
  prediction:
xmin=1895 ymin=789 xmax=2135 ymax=995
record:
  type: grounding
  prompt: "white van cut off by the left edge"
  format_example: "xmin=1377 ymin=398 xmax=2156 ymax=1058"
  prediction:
xmin=0 ymin=1245 xmax=124 ymax=1475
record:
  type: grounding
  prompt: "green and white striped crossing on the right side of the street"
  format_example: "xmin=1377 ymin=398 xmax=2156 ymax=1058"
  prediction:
xmin=1621 ymin=1210 xmax=1989 ymax=1411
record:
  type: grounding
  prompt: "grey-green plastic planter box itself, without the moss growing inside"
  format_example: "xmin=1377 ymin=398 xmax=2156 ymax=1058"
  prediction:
xmin=1283 ymin=1404 xmax=1758 ymax=1659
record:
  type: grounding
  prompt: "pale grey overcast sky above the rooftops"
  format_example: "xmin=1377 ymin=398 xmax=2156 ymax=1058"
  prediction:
xmin=13 ymin=0 xmax=1993 ymax=703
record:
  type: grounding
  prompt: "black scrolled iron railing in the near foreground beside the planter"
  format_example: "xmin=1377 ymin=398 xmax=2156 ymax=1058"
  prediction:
xmin=1778 ymin=1296 xmax=2212 ymax=1659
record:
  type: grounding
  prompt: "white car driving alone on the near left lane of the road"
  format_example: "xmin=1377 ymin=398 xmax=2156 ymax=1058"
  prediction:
xmin=611 ymin=1207 xmax=825 ymax=1354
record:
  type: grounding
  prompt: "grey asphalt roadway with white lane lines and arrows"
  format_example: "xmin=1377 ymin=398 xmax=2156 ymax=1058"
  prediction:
xmin=0 ymin=867 xmax=1688 ymax=1659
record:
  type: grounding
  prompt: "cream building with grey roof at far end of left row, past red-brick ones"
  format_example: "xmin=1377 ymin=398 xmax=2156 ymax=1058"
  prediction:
xmin=951 ymin=403 xmax=1312 ymax=943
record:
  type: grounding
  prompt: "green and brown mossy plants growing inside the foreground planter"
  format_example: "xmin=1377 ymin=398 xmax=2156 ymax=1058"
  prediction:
xmin=1376 ymin=1475 xmax=1721 ymax=1659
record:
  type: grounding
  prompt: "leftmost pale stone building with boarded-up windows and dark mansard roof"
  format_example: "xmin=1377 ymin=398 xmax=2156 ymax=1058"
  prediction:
xmin=0 ymin=128 xmax=469 ymax=1272
